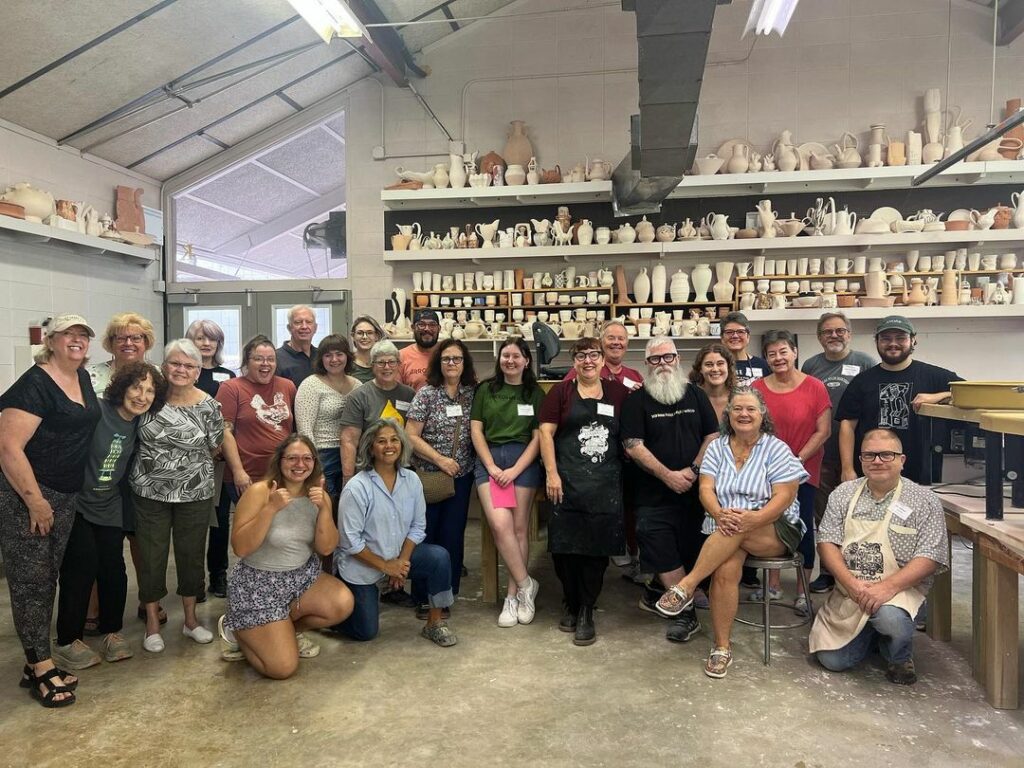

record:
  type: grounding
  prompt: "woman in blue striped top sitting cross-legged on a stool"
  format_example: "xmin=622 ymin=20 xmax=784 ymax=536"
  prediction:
xmin=657 ymin=387 xmax=808 ymax=678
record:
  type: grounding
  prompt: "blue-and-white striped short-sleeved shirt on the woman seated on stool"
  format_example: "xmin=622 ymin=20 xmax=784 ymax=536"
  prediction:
xmin=700 ymin=434 xmax=810 ymax=535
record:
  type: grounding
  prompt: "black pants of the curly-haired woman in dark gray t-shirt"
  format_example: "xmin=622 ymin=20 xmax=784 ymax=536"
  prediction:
xmin=57 ymin=514 xmax=128 ymax=645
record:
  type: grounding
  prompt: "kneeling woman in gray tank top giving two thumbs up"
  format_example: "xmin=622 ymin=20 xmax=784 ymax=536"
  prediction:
xmin=219 ymin=434 xmax=352 ymax=680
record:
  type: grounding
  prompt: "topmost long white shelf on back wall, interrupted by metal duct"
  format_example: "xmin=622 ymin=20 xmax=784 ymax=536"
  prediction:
xmin=381 ymin=160 xmax=1024 ymax=211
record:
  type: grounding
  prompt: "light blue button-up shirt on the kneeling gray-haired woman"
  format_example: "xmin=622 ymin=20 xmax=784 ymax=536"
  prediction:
xmin=335 ymin=467 xmax=427 ymax=584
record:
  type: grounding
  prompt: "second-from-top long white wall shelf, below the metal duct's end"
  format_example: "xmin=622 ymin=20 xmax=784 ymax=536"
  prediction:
xmin=384 ymin=229 xmax=1024 ymax=264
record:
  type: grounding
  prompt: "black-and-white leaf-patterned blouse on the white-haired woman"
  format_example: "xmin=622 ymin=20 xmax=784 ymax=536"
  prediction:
xmin=130 ymin=395 xmax=224 ymax=504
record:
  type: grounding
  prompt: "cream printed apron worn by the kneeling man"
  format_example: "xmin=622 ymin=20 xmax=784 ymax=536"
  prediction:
xmin=808 ymin=479 xmax=925 ymax=653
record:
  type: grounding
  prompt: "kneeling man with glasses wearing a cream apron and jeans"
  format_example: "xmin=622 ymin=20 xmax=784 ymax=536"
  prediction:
xmin=810 ymin=429 xmax=949 ymax=685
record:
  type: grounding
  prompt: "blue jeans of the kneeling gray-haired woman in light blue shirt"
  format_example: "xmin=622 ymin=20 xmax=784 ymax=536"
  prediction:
xmin=331 ymin=544 xmax=455 ymax=640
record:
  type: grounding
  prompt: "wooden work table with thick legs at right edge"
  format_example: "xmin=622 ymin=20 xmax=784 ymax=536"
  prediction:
xmin=928 ymin=486 xmax=1024 ymax=710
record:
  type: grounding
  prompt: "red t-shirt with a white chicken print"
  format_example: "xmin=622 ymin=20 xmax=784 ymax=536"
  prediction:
xmin=217 ymin=376 xmax=295 ymax=482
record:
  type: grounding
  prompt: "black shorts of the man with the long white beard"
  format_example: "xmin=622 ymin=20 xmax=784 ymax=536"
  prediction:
xmin=637 ymin=495 xmax=707 ymax=573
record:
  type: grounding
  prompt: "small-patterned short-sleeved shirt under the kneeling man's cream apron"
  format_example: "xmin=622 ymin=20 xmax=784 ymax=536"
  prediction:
xmin=818 ymin=477 xmax=949 ymax=592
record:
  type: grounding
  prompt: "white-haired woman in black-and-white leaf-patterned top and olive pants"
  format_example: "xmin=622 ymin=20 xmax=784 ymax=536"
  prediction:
xmin=130 ymin=339 xmax=236 ymax=653
